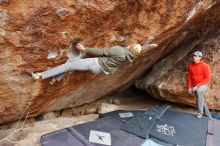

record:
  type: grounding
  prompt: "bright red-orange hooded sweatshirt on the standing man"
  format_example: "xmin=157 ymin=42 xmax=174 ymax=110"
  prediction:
xmin=188 ymin=61 xmax=211 ymax=88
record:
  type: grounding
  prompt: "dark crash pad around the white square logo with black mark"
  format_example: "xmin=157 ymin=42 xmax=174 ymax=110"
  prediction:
xmin=41 ymin=116 xmax=144 ymax=146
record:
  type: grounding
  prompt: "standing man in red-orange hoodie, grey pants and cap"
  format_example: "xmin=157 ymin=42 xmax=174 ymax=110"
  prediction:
xmin=188 ymin=51 xmax=212 ymax=118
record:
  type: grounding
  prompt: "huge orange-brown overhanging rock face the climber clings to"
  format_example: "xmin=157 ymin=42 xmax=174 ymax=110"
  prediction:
xmin=0 ymin=0 xmax=219 ymax=123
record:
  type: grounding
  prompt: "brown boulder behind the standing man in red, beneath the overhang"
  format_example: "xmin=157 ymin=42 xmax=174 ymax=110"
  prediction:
xmin=135 ymin=28 xmax=220 ymax=110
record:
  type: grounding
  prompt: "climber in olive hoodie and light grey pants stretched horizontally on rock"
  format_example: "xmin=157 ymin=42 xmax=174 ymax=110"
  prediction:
xmin=31 ymin=39 xmax=157 ymax=83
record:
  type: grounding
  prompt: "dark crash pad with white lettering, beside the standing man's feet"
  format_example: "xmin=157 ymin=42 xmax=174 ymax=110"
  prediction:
xmin=150 ymin=110 xmax=208 ymax=146
